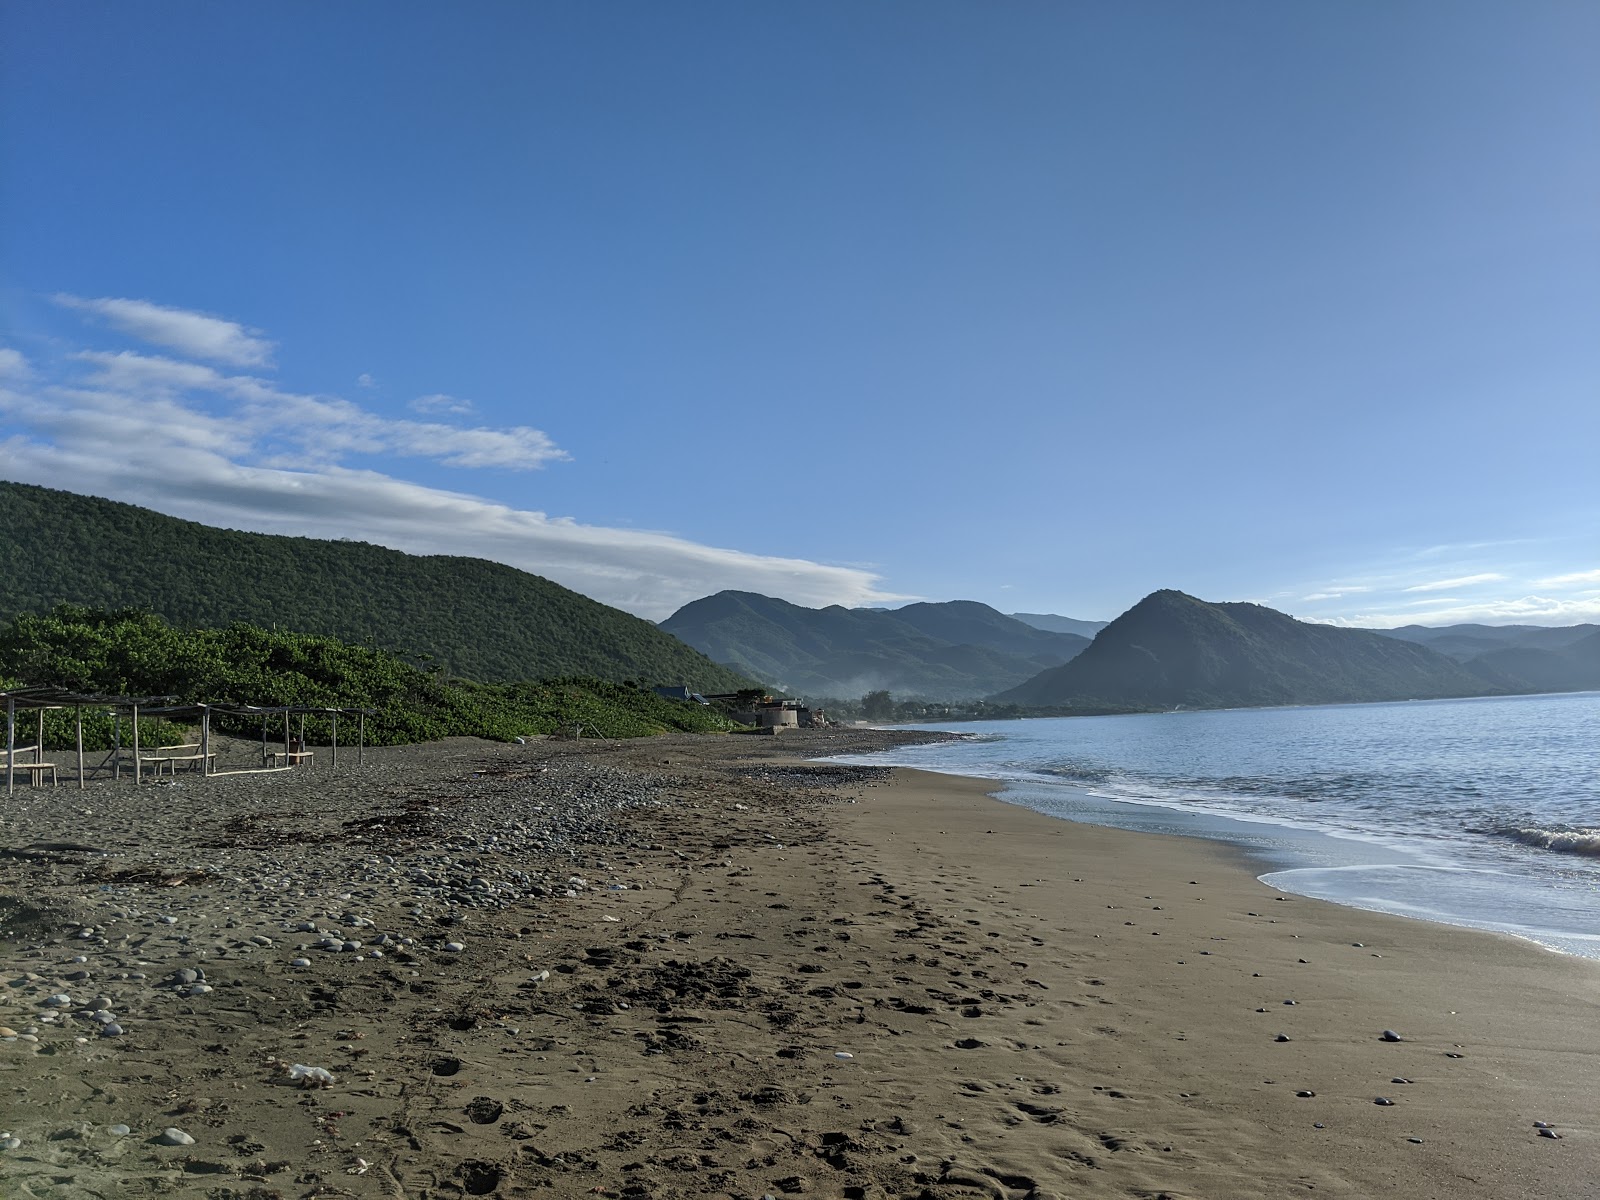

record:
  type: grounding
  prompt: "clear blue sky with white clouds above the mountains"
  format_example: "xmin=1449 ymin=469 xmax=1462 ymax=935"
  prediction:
xmin=0 ymin=0 xmax=1600 ymax=627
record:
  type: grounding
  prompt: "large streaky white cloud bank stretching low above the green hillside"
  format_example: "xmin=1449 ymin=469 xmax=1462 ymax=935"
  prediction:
xmin=0 ymin=310 xmax=907 ymax=619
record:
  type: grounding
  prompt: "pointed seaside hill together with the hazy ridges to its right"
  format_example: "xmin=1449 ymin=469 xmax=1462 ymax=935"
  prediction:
xmin=994 ymin=590 xmax=1600 ymax=709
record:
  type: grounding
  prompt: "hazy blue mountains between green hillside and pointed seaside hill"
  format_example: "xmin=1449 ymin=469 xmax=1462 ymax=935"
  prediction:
xmin=661 ymin=592 xmax=1088 ymax=699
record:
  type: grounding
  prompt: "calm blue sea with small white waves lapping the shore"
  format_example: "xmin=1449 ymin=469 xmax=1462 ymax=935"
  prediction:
xmin=850 ymin=691 xmax=1600 ymax=958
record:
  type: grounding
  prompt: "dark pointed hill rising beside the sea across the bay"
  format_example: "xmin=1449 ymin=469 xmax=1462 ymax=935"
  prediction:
xmin=994 ymin=590 xmax=1494 ymax=709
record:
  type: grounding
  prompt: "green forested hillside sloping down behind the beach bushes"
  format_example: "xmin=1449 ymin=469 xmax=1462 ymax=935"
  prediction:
xmin=0 ymin=483 xmax=749 ymax=691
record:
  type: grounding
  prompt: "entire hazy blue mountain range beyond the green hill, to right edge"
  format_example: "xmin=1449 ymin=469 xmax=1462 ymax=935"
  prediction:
xmin=662 ymin=590 xmax=1600 ymax=710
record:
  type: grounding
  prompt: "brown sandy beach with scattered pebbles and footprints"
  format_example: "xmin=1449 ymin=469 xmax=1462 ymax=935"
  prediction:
xmin=0 ymin=731 xmax=1600 ymax=1200
